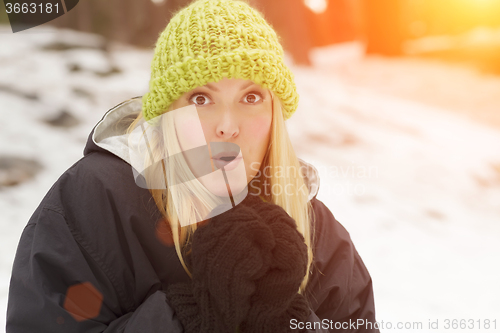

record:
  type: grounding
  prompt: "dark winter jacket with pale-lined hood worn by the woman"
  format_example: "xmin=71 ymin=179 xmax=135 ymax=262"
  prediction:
xmin=6 ymin=97 xmax=378 ymax=333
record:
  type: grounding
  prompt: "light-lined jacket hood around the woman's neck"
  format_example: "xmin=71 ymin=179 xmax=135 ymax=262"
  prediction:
xmin=83 ymin=96 xmax=319 ymax=200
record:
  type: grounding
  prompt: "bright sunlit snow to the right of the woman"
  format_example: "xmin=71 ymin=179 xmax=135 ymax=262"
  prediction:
xmin=289 ymin=45 xmax=500 ymax=332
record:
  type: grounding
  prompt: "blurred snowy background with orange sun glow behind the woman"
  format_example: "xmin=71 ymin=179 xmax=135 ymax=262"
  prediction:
xmin=0 ymin=0 xmax=500 ymax=332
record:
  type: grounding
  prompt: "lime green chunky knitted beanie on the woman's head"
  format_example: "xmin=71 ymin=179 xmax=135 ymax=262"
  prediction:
xmin=142 ymin=0 xmax=299 ymax=120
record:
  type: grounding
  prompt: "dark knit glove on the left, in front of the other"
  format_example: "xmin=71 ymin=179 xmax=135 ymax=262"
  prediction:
xmin=166 ymin=196 xmax=275 ymax=333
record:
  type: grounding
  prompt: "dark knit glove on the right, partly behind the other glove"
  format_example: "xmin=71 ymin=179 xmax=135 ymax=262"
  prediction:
xmin=241 ymin=196 xmax=310 ymax=333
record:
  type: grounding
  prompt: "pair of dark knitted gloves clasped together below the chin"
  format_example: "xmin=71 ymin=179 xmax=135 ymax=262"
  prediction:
xmin=166 ymin=195 xmax=310 ymax=333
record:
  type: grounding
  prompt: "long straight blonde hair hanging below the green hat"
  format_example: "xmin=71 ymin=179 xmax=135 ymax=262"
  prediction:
xmin=127 ymin=91 xmax=313 ymax=293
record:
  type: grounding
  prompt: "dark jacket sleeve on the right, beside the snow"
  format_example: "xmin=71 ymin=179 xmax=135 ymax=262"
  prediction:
xmin=306 ymin=199 xmax=379 ymax=333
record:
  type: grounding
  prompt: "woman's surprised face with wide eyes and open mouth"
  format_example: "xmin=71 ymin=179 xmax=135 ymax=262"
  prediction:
xmin=173 ymin=78 xmax=272 ymax=192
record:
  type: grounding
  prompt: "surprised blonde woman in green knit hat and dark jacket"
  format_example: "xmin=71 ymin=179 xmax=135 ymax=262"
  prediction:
xmin=7 ymin=0 xmax=378 ymax=333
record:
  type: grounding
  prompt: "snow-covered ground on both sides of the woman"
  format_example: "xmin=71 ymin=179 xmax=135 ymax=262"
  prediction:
xmin=0 ymin=27 xmax=500 ymax=332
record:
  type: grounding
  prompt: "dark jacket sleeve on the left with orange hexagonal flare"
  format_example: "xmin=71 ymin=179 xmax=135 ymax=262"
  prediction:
xmin=6 ymin=205 xmax=182 ymax=333
